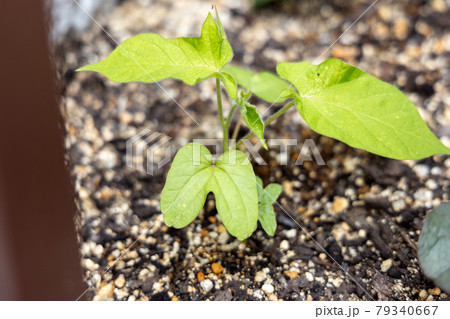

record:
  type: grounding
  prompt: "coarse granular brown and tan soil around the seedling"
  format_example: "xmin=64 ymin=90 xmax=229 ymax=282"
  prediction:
xmin=56 ymin=0 xmax=450 ymax=300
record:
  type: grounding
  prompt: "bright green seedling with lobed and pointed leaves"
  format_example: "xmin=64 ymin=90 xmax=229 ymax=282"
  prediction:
xmin=78 ymin=11 xmax=450 ymax=240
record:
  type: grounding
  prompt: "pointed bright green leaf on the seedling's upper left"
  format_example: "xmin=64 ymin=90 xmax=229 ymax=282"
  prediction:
xmin=78 ymin=14 xmax=233 ymax=91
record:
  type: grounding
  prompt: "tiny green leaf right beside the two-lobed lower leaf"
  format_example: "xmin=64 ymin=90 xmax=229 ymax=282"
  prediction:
xmin=256 ymin=177 xmax=283 ymax=236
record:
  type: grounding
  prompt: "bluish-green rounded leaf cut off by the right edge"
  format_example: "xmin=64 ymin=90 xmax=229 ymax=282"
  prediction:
xmin=417 ymin=202 xmax=450 ymax=293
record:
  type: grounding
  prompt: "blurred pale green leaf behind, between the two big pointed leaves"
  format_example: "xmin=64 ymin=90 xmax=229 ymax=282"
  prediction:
xmin=222 ymin=65 xmax=290 ymax=103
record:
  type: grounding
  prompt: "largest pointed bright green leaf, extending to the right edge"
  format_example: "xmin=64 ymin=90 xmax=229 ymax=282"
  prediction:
xmin=277 ymin=59 xmax=450 ymax=159
